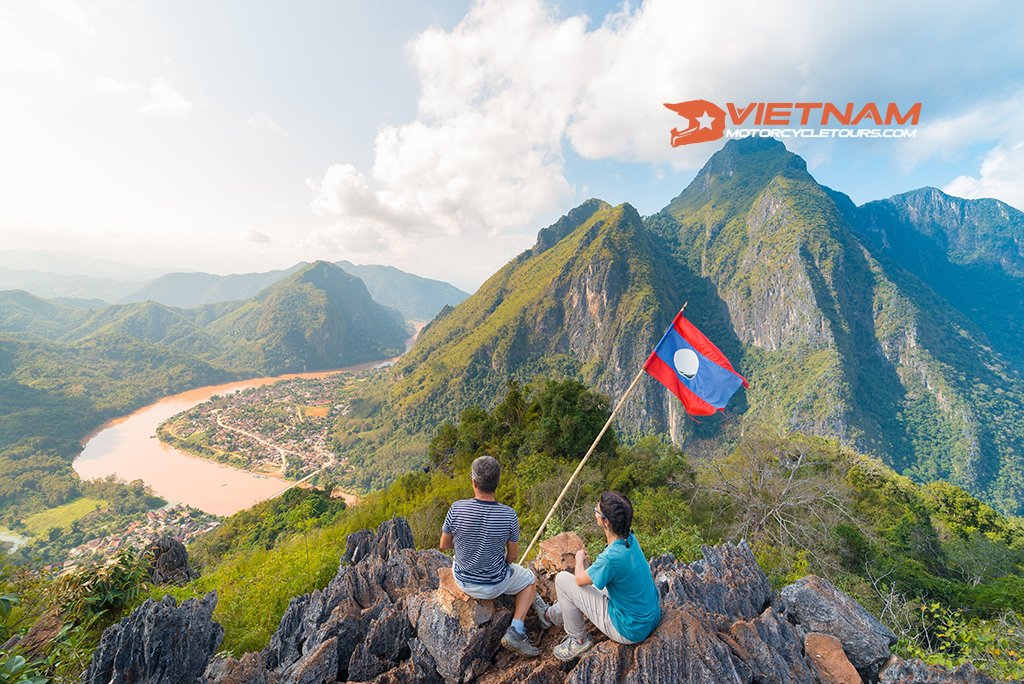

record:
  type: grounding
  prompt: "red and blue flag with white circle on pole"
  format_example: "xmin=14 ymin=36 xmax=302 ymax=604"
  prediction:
xmin=643 ymin=311 xmax=748 ymax=416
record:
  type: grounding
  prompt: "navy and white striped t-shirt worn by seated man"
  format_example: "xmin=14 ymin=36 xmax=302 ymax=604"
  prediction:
xmin=441 ymin=499 xmax=519 ymax=585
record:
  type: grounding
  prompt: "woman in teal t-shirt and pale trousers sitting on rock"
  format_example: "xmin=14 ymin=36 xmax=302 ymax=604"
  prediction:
xmin=534 ymin=491 xmax=662 ymax=660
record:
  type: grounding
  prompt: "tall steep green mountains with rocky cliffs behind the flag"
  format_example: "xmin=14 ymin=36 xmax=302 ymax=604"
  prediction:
xmin=346 ymin=139 xmax=1024 ymax=513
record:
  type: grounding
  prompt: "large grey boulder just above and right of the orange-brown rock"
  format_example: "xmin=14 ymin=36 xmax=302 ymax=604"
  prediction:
xmin=781 ymin=574 xmax=896 ymax=680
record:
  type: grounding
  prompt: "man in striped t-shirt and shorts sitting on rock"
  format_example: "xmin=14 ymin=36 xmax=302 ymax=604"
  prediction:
xmin=440 ymin=456 xmax=541 ymax=656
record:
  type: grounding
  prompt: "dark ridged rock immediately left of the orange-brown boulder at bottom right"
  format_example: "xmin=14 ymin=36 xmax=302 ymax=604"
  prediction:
xmin=720 ymin=608 xmax=815 ymax=684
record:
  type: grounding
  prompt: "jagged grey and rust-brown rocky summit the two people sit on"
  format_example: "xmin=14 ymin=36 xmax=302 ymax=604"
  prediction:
xmin=85 ymin=518 xmax=1007 ymax=684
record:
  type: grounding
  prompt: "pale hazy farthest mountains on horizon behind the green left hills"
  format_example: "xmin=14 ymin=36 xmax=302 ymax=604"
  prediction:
xmin=0 ymin=255 xmax=469 ymax=323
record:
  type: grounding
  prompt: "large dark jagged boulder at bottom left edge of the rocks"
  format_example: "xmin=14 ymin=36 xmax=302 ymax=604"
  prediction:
xmin=82 ymin=592 xmax=224 ymax=684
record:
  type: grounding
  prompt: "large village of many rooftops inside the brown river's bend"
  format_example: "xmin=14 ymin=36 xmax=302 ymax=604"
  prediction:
xmin=158 ymin=374 xmax=351 ymax=480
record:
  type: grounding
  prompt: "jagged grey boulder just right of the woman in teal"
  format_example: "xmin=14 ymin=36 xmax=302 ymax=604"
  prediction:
xmin=652 ymin=542 xmax=772 ymax=619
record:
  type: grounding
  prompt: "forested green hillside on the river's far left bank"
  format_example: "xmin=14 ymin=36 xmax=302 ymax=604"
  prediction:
xmin=0 ymin=262 xmax=408 ymax=522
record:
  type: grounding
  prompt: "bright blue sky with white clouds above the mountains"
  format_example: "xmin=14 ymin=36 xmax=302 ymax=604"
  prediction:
xmin=0 ymin=0 xmax=1024 ymax=289
